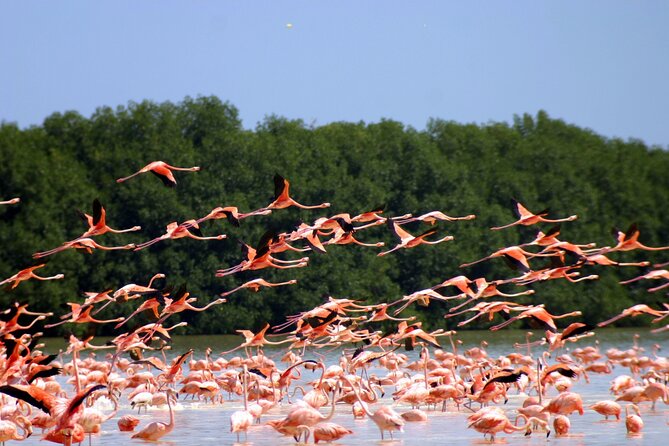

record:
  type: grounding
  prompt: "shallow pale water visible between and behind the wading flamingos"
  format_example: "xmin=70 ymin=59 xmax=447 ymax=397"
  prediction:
xmin=13 ymin=329 xmax=669 ymax=446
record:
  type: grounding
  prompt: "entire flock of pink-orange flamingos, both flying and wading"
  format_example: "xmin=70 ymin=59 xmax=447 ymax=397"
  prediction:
xmin=0 ymin=161 xmax=669 ymax=445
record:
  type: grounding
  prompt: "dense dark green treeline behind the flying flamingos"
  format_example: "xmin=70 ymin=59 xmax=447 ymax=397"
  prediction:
xmin=0 ymin=97 xmax=669 ymax=334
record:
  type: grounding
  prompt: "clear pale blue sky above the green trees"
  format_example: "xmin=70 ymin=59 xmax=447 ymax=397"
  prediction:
xmin=0 ymin=0 xmax=669 ymax=147
